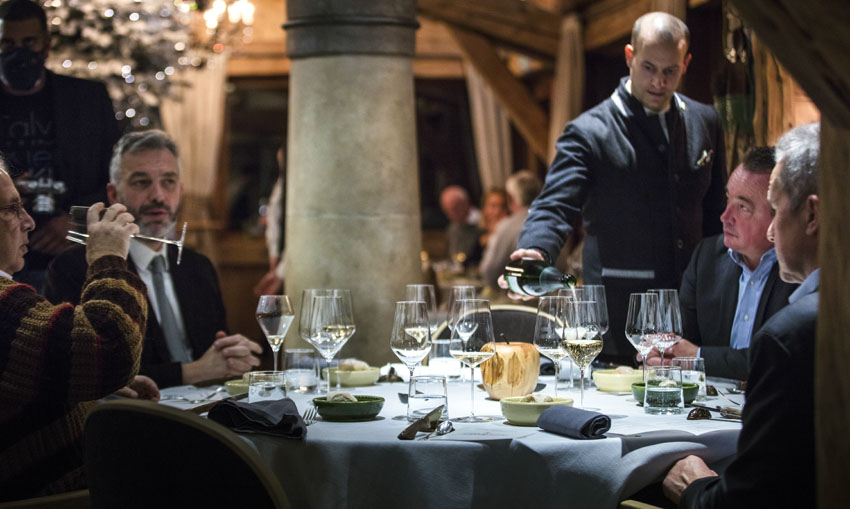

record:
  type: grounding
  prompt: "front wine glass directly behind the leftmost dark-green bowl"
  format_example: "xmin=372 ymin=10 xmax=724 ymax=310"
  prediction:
xmin=302 ymin=290 xmax=355 ymax=392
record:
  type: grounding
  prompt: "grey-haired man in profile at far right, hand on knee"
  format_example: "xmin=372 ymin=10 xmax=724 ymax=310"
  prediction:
xmin=662 ymin=124 xmax=820 ymax=509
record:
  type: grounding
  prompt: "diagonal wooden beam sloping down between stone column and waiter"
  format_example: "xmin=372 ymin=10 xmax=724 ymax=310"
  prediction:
xmin=449 ymin=26 xmax=549 ymax=161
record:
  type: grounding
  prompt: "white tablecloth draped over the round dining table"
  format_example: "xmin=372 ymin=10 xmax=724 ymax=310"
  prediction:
xmin=157 ymin=377 xmax=740 ymax=508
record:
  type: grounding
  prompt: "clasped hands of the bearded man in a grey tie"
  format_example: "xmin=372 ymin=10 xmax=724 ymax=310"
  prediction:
xmin=183 ymin=331 xmax=263 ymax=384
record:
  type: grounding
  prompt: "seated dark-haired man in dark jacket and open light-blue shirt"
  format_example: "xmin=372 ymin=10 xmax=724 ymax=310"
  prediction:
xmin=647 ymin=147 xmax=797 ymax=380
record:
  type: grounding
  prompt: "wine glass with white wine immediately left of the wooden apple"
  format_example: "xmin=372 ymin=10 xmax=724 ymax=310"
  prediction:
xmin=449 ymin=299 xmax=495 ymax=422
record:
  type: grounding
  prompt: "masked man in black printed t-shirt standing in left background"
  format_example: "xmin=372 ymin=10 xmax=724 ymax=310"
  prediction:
xmin=0 ymin=0 xmax=119 ymax=290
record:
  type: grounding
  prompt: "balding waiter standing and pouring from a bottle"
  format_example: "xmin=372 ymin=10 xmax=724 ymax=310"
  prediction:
xmin=499 ymin=12 xmax=726 ymax=364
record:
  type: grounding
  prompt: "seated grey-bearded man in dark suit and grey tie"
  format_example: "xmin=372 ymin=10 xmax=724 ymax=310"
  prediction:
xmin=45 ymin=130 xmax=262 ymax=387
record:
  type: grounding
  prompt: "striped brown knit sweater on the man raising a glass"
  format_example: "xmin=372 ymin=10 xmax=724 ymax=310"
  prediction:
xmin=0 ymin=256 xmax=147 ymax=500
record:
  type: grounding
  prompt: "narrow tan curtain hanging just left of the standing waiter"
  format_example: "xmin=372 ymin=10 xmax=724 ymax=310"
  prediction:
xmin=549 ymin=14 xmax=584 ymax=161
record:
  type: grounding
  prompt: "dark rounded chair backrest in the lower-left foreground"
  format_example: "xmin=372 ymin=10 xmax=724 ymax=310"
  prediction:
xmin=84 ymin=400 xmax=289 ymax=509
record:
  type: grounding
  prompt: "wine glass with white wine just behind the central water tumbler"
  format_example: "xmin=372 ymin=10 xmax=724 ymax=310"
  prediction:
xmin=390 ymin=301 xmax=431 ymax=415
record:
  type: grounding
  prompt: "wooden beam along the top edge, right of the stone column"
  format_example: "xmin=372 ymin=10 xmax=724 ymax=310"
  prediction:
xmin=416 ymin=0 xmax=561 ymax=59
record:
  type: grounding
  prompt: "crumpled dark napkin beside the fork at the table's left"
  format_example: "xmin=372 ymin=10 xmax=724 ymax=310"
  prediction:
xmin=207 ymin=398 xmax=307 ymax=439
